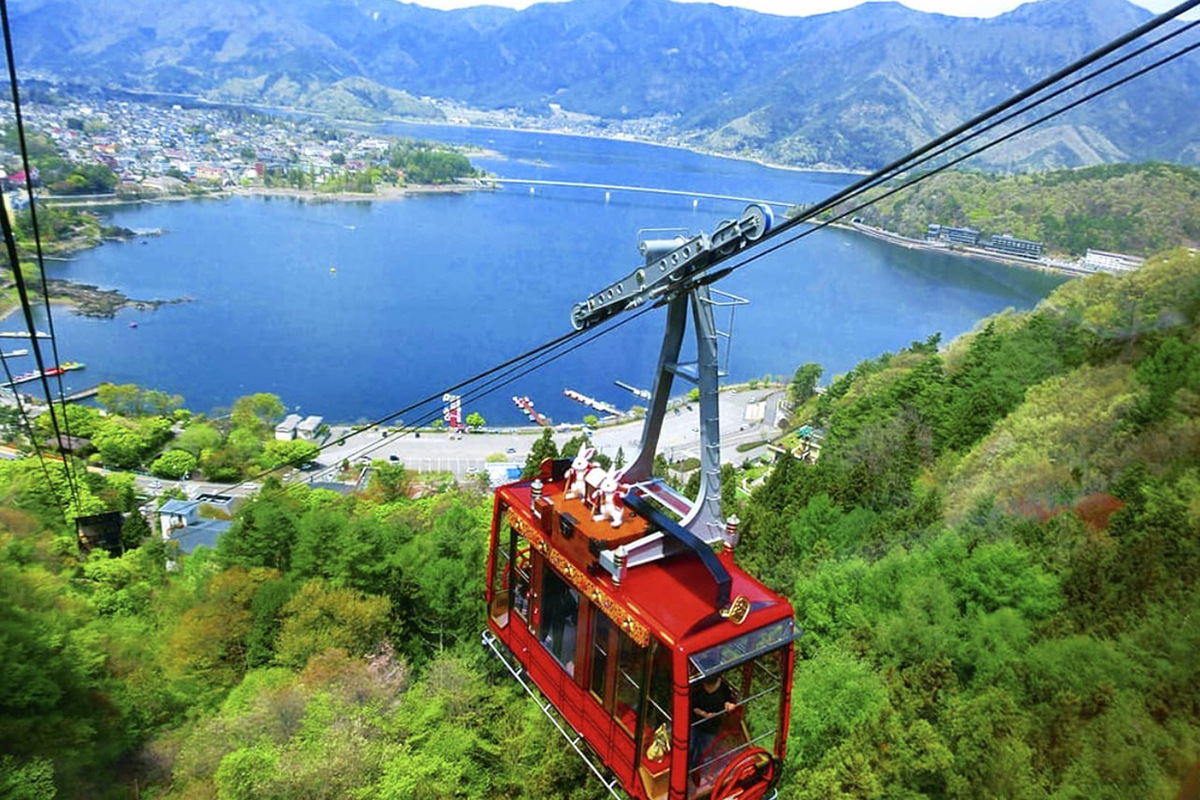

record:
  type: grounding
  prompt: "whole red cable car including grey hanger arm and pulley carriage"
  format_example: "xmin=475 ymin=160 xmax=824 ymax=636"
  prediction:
xmin=484 ymin=206 xmax=794 ymax=800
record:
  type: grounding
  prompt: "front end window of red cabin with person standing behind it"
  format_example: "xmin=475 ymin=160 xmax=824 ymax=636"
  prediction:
xmin=688 ymin=647 xmax=787 ymax=796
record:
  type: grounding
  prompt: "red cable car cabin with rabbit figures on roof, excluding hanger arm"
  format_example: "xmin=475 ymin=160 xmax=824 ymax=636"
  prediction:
xmin=484 ymin=461 xmax=794 ymax=800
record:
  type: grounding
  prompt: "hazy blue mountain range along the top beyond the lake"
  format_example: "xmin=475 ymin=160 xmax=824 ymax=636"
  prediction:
xmin=11 ymin=0 xmax=1200 ymax=169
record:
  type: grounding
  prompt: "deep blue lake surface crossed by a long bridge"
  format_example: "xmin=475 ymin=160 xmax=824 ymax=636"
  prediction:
xmin=23 ymin=126 xmax=1062 ymax=425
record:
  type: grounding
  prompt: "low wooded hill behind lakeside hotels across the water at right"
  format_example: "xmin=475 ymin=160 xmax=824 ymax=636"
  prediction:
xmin=842 ymin=163 xmax=1200 ymax=257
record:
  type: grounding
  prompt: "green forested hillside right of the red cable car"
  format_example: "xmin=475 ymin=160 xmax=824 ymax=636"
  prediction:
xmin=743 ymin=251 xmax=1200 ymax=800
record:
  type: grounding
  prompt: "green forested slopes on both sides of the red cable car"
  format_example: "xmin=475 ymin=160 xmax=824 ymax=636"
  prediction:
xmin=0 ymin=249 xmax=1200 ymax=800
